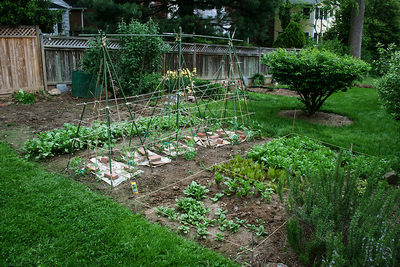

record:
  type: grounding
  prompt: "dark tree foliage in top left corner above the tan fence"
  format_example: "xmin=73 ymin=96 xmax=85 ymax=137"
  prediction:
xmin=0 ymin=0 xmax=61 ymax=32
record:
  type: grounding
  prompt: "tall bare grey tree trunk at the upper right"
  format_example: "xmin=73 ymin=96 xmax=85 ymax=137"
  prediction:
xmin=349 ymin=0 xmax=365 ymax=58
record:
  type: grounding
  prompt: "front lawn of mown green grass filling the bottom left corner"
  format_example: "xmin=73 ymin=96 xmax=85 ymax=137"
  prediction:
xmin=0 ymin=143 xmax=235 ymax=266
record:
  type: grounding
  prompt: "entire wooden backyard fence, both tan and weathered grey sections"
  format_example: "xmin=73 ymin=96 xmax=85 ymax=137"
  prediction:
xmin=0 ymin=26 xmax=272 ymax=96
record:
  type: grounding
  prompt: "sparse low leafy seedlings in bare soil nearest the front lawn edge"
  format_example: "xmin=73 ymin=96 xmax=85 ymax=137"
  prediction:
xmin=157 ymin=181 xmax=266 ymax=241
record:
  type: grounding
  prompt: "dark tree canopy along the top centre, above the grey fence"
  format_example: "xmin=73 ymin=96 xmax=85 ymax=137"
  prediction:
xmin=82 ymin=0 xmax=280 ymax=44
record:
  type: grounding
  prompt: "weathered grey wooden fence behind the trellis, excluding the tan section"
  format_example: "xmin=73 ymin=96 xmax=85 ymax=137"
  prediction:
xmin=42 ymin=36 xmax=272 ymax=85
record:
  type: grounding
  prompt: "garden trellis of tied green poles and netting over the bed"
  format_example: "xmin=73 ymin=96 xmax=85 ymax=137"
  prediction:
xmin=67 ymin=28 xmax=255 ymax=188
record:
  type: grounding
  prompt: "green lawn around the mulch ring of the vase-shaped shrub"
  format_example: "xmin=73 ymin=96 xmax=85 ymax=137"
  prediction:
xmin=250 ymin=88 xmax=400 ymax=158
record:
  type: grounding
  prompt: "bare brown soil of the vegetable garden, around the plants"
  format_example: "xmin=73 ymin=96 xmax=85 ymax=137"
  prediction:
xmin=0 ymin=88 xmax=350 ymax=266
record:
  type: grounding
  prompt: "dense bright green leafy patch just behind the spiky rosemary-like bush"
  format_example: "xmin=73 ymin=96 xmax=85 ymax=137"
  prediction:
xmin=247 ymin=136 xmax=392 ymax=181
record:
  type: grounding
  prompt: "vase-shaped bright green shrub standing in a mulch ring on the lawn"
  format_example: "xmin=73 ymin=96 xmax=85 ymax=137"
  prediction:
xmin=261 ymin=48 xmax=369 ymax=116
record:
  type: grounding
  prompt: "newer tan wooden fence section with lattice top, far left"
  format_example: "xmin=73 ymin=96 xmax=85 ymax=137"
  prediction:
xmin=0 ymin=26 xmax=44 ymax=96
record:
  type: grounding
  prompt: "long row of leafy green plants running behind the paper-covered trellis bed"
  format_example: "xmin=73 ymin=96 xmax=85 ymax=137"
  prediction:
xmin=23 ymin=115 xmax=200 ymax=159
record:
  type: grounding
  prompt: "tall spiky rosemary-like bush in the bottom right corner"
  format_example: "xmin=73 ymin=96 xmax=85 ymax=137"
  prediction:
xmin=280 ymin=155 xmax=400 ymax=266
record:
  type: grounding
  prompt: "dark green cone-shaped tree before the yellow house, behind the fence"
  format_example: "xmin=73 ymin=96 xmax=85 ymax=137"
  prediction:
xmin=273 ymin=21 xmax=306 ymax=48
